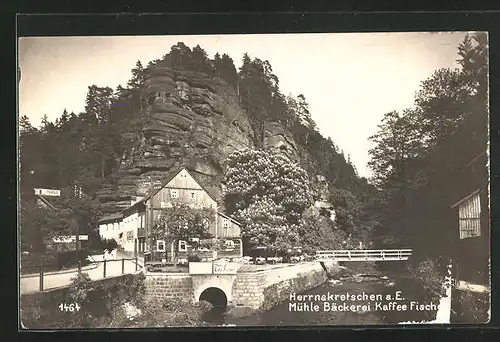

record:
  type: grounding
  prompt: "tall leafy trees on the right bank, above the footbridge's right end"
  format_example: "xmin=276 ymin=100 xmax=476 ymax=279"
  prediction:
xmin=370 ymin=33 xmax=488 ymax=259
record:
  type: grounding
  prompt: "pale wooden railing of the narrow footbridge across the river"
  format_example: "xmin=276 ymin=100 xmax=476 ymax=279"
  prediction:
xmin=316 ymin=249 xmax=412 ymax=260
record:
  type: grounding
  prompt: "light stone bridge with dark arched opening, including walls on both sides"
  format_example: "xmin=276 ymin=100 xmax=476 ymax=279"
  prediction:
xmin=145 ymin=262 xmax=340 ymax=309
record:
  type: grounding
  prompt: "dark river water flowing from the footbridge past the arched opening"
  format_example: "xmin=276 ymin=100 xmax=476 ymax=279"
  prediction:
xmin=201 ymin=269 xmax=434 ymax=326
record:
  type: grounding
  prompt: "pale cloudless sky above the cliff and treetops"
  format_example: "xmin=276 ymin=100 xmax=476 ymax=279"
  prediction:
xmin=18 ymin=32 xmax=466 ymax=177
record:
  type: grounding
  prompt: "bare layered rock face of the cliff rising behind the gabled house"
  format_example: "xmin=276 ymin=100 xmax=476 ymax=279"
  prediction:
xmin=99 ymin=67 xmax=328 ymax=213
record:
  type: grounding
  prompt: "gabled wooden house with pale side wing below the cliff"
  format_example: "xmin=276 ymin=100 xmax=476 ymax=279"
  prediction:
xmin=99 ymin=168 xmax=243 ymax=260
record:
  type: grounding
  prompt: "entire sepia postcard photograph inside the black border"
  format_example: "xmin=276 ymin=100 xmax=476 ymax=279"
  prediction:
xmin=17 ymin=31 xmax=491 ymax=330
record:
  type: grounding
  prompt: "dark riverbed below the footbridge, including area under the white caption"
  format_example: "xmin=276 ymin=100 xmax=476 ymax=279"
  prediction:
xmin=204 ymin=263 xmax=448 ymax=327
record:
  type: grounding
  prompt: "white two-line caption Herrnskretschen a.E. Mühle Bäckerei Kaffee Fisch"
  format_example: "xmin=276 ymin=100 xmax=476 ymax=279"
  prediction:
xmin=288 ymin=291 xmax=437 ymax=312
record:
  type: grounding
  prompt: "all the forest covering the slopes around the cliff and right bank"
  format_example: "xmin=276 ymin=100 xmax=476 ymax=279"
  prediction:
xmin=19 ymin=35 xmax=487 ymax=260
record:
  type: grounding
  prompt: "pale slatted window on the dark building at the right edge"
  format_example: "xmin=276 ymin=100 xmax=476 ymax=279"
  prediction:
xmin=458 ymin=193 xmax=481 ymax=239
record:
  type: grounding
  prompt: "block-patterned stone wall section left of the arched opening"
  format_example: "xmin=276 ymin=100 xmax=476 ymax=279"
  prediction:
xmin=144 ymin=272 xmax=194 ymax=299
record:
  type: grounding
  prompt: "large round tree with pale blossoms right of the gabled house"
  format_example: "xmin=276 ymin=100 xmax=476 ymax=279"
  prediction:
xmin=224 ymin=150 xmax=312 ymax=251
